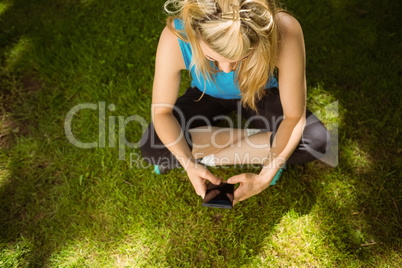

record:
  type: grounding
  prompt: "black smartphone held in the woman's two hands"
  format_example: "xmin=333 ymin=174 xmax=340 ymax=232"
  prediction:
xmin=202 ymin=182 xmax=234 ymax=209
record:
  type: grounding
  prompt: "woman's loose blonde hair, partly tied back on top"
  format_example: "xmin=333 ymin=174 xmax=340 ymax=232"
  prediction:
xmin=165 ymin=0 xmax=278 ymax=110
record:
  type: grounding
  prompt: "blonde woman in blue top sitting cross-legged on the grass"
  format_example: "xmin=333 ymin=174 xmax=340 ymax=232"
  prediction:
xmin=140 ymin=0 xmax=329 ymax=205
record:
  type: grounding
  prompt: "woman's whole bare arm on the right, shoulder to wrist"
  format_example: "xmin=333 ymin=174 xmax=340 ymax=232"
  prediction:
xmin=260 ymin=13 xmax=306 ymax=182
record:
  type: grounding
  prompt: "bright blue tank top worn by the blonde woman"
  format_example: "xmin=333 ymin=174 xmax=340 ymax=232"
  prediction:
xmin=174 ymin=19 xmax=278 ymax=99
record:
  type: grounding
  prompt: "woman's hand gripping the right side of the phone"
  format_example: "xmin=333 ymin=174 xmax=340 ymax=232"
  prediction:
xmin=227 ymin=173 xmax=270 ymax=206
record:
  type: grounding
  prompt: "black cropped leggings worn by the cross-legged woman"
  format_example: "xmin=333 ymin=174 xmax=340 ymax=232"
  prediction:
xmin=140 ymin=87 xmax=330 ymax=167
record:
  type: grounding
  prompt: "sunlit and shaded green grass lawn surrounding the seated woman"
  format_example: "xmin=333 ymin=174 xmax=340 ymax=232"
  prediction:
xmin=0 ymin=0 xmax=402 ymax=267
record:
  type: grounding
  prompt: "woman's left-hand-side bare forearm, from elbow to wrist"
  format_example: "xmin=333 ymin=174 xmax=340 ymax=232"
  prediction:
xmin=153 ymin=113 xmax=194 ymax=169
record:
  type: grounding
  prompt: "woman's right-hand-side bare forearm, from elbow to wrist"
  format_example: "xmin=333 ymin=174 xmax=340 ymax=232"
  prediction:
xmin=260 ymin=117 xmax=305 ymax=179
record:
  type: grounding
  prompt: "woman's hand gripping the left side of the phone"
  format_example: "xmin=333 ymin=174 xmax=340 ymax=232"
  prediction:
xmin=186 ymin=163 xmax=222 ymax=199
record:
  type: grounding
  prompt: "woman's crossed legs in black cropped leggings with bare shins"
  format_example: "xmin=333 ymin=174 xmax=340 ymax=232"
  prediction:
xmin=140 ymin=88 xmax=330 ymax=168
